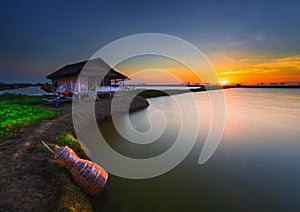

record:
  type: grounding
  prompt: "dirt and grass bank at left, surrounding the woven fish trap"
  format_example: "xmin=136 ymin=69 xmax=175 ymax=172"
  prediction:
xmin=0 ymin=94 xmax=93 ymax=211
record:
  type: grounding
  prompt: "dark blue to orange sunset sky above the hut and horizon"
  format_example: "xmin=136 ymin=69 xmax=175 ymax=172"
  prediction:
xmin=0 ymin=0 xmax=300 ymax=84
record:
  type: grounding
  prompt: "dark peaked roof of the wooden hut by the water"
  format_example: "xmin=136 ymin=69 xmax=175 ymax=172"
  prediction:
xmin=47 ymin=58 xmax=129 ymax=80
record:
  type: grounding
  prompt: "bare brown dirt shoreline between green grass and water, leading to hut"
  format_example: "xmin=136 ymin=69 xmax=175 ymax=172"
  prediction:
xmin=0 ymin=97 xmax=148 ymax=211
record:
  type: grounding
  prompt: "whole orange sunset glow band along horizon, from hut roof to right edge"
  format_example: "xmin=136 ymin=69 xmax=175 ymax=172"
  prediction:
xmin=116 ymin=55 xmax=300 ymax=85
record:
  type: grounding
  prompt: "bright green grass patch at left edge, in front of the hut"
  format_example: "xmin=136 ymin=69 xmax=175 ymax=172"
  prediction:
xmin=0 ymin=94 xmax=57 ymax=136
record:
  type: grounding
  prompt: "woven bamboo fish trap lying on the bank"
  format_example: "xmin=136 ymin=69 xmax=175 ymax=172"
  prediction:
xmin=42 ymin=141 xmax=108 ymax=195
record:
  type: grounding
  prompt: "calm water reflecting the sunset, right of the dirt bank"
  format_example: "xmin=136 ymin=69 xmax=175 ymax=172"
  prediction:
xmin=92 ymin=89 xmax=300 ymax=211
